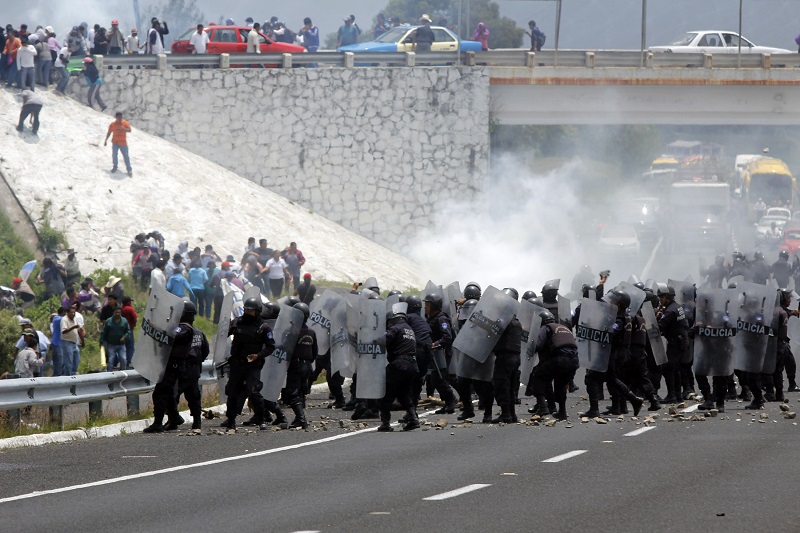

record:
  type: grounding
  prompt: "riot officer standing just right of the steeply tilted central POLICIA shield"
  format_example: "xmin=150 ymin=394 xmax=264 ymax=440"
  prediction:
xmin=491 ymin=288 xmax=522 ymax=424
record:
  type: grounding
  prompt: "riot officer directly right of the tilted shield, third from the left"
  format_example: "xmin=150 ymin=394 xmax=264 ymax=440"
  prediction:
xmin=286 ymin=302 xmax=319 ymax=429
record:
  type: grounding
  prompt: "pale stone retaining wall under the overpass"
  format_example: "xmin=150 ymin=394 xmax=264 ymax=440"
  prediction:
xmin=71 ymin=67 xmax=489 ymax=249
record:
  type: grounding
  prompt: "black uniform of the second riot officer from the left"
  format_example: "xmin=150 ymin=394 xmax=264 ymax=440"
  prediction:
xmin=225 ymin=313 xmax=275 ymax=428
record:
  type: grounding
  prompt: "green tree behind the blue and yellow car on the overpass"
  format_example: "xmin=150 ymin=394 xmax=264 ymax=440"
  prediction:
xmin=380 ymin=0 xmax=524 ymax=48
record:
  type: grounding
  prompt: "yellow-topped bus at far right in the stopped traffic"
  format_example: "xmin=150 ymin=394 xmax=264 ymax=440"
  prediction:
xmin=741 ymin=157 xmax=797 ymax=222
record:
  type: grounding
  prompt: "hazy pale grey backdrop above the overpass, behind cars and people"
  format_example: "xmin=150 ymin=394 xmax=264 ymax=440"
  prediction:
xmin=0 ymin=0 xmax=800 ymax=49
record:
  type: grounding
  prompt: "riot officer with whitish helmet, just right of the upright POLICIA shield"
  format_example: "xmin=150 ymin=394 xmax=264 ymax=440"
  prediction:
xmin=378 ymin=302 xmax=419 ymax=431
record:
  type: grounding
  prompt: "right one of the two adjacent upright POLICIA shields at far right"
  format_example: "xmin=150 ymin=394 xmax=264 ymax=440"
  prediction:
xmin=734 ymin=281 xmax=778 ymax=373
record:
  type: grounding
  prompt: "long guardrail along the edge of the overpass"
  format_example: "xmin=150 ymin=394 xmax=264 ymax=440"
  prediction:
xmin=95 ymin=49 xmax=800 ymax=70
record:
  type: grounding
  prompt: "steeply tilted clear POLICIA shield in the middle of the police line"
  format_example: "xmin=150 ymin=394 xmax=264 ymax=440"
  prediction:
xmin=453 ymin=285 xmax=519 ymax=363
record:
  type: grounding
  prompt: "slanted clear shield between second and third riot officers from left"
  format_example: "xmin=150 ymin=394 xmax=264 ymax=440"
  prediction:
xmin=261 ymin=304 xmax=303 ymax=402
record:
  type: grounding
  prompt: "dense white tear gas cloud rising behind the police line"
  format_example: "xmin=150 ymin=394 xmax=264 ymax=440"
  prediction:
xmin=412 ymin=156 xmax=596 ymax=294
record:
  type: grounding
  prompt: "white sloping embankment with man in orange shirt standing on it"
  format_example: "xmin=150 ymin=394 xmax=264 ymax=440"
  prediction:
xmin=0 ymin=89 xmax=421 ymax=288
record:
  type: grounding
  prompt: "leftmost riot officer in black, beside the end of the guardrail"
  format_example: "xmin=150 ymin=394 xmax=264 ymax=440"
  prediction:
xmin=144 ymin=301 xmax=209 ymax=433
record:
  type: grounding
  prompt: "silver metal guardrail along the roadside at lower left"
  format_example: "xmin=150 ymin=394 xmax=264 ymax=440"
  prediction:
xmin=0 ymin=361 xmax=217 ymax=410
